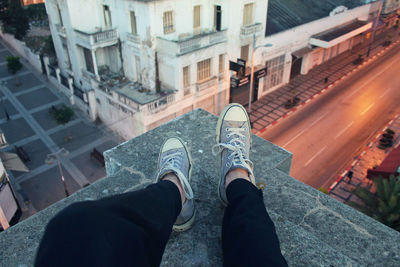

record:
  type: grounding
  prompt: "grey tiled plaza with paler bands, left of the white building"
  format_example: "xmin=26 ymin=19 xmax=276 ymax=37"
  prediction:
xmin=0 ymin=41 xmax=122 ymax=218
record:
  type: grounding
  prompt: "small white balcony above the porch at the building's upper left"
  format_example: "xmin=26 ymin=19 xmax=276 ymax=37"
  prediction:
xmin=75 ymin=29 xmax=119 ymax=49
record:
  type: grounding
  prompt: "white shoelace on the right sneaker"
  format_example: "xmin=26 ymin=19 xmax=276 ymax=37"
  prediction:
xmin=212 ymin=128 xmax=254 ymax=179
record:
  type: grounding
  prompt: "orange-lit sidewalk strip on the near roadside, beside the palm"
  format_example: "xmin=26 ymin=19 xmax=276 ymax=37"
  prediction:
xmin=329 ymin=114 xmax=400 ymax=202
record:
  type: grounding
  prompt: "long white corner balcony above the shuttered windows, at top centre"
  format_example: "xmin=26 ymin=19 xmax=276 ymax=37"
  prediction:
xmin=157 ymin=30 xmax=227 ymax=56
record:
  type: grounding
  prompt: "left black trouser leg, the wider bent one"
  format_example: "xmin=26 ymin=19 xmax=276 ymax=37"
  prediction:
xmin=35 ymin=181 xmax=181 ymax=267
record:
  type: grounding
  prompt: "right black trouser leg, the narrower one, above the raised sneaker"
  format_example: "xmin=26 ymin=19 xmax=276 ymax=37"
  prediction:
xmin=222 ymin=179 xmax=287 ymax=267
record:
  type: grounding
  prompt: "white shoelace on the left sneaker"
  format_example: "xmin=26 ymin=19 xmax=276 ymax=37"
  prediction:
xmin=160 ymin=151 xmax=193 ymax=199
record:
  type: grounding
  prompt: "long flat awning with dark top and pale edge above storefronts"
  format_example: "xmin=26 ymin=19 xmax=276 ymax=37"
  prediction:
xmin=310 ymin=20 xmax=372 ymax=48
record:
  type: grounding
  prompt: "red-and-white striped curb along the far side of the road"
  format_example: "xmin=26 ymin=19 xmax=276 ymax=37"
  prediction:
xmin=255 ymin=39 xmax=400 ymax=135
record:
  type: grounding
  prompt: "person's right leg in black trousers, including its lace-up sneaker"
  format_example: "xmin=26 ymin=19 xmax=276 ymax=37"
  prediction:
xmin=213 ymin=104 xmax=287 ymax=266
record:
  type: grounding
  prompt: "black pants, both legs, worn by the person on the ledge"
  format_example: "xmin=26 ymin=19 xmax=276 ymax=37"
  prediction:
xmin=35 ymin=179 xmax=287 ymax=267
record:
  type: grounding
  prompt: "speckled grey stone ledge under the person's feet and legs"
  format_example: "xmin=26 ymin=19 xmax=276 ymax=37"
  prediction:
xmin=0 ymin=110 xmax=400 ymax=266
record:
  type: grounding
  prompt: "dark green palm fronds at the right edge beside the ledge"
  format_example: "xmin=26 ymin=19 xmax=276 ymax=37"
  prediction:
xmin=348 ymin=176 xmax=400 ymax=231
